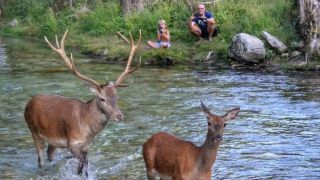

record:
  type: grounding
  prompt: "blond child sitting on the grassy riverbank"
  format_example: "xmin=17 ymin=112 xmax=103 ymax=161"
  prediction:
xmin=148 ymin=20 xmax=170 ymax=48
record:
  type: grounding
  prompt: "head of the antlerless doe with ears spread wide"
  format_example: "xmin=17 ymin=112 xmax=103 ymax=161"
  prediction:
xmin=201 ymin=102 xmax=240 ymax=142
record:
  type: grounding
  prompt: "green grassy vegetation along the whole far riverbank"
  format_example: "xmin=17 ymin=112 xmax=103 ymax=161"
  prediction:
xmin=0 ymin=0 xmax=306 ymax=69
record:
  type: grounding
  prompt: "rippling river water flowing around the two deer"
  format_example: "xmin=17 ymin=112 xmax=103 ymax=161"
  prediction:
xmin=0 ymin=38 xmax=320 ymax=180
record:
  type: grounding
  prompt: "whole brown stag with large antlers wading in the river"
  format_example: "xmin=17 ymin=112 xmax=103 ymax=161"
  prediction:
xmin=24 ymin=30 xmax=141 ymax=175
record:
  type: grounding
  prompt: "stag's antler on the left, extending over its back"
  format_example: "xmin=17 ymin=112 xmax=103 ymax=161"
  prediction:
xmin=44 ymin=30 xmax=100 ymax=89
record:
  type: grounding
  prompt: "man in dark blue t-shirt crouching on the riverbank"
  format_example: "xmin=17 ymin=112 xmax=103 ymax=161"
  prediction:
xmin=189 ymin=4 xmax=218 ymax=41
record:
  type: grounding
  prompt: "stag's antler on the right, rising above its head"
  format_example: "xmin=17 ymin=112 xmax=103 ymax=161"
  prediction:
xmin=115 ymin=29 xmax=141 ymax=87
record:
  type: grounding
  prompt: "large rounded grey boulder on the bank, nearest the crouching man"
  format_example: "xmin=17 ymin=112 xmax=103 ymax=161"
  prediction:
xmin=228 ymin=33 xmax=266 ymax=63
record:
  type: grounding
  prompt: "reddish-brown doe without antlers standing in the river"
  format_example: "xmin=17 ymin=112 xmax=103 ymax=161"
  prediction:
xmin=143 ymin=102 xmax=240 ymax=180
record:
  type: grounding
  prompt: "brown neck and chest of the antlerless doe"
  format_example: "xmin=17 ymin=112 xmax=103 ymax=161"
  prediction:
xmin=199 ymin=130 xmax=220 ymax=171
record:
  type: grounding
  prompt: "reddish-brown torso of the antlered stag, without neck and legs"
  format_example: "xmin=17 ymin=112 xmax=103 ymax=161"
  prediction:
xmin=24 ymin=95 xmax=84 ymax=143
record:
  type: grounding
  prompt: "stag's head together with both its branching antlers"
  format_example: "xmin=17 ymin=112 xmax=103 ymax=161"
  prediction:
xmin=45 ymin=30 xmax=141 ymax=121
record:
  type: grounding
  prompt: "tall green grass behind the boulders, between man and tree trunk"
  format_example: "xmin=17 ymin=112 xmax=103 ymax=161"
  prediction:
xmin=213 ymin=0 xmax=296 ymax=42
